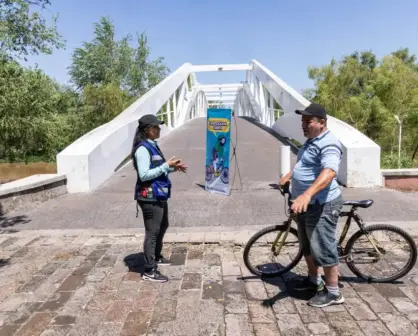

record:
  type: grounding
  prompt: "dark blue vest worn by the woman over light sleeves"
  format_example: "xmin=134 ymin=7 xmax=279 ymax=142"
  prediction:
xmin=134 ymin=141 xmax=171 ymax=201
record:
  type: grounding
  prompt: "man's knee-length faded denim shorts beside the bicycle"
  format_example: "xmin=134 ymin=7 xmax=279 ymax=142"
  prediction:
xmin=297 ymin=195 xmax=343 ymax=267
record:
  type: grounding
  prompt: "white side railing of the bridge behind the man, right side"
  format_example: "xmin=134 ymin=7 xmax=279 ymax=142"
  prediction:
xmin=244 ymin=60 xmax=382 ymax=187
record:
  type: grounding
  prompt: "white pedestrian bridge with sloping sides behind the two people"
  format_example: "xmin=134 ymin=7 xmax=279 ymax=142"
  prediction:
xmin=57 ymin=60 xmax=382 ymax=193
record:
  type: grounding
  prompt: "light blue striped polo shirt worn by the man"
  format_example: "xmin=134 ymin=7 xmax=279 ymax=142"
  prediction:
xmin=292 ymin=129 xmax=343 ymax=204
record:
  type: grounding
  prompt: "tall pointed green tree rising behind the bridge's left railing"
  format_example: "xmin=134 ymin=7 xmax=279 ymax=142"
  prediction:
xmin=69 ymin=17 xmax=169 ymax=96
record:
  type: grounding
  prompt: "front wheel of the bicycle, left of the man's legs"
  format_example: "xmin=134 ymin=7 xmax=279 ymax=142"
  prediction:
xmin=243 ymin=225 xmax=302 ymax=277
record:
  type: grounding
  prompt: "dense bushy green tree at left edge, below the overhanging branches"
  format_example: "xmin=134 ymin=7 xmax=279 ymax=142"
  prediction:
xmin=0 ymin=60 xmax=70 ymax=162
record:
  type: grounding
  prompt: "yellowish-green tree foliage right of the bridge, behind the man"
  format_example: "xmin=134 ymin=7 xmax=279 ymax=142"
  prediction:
xmin=305 ymin=49 xmax=418 ymax=168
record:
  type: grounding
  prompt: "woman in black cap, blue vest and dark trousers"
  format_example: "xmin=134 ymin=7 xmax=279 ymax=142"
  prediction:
xmin=131 ymin=114 xmax=187 ymax=282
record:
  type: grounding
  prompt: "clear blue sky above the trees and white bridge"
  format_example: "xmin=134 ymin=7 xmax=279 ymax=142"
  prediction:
xmin=26 ymin=0 xmax=418 ymax=90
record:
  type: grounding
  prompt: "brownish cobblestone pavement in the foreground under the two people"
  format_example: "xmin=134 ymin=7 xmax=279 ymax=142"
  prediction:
xmin=0 ymin=230 xmax=418 ymax=336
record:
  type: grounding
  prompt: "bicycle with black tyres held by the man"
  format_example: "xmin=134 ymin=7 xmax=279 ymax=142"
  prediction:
xmin=243 ymin=184 xmax=417 ymax=283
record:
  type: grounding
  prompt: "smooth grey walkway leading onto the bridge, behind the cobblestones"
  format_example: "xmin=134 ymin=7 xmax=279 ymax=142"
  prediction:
xmin=0 ymin=118 xmax=418 ymax=231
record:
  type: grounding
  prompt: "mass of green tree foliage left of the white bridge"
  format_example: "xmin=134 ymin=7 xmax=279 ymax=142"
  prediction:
xmin=0 ymin=13 xmax=168 ymax=162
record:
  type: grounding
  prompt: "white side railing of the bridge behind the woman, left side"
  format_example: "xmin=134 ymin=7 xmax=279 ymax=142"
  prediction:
xmin=57 ymin=63 xmax=201 ymax=193
